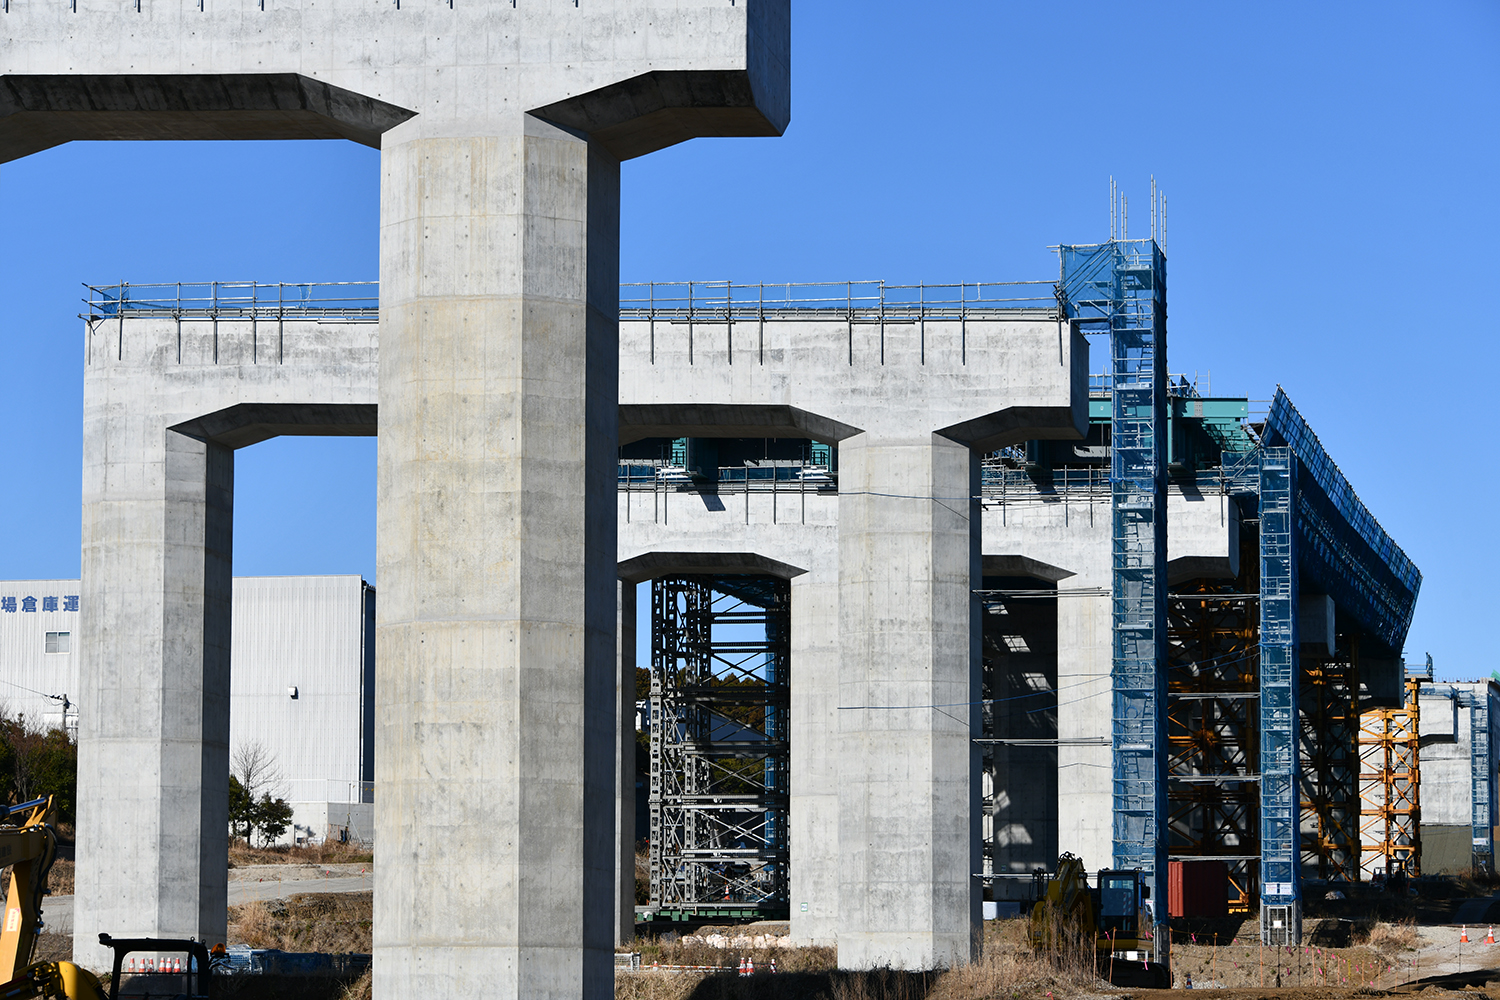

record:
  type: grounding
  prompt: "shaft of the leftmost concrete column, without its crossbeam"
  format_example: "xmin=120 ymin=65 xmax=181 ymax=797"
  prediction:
xmin=75 ymin=428 xmax=234 ymax=966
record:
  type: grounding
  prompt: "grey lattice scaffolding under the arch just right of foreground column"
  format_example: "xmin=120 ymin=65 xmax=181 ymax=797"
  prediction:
xmin=651 ymin=576 xmax=791 ymax=919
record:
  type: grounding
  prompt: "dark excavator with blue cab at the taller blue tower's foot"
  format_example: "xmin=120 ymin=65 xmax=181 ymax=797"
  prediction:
xmin=1029 ymin=853 xmax=1172 ymax=988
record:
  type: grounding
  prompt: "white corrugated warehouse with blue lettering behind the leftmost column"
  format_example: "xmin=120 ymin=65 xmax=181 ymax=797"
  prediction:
xmin=0 ymin=576 xmax=375 ymax=815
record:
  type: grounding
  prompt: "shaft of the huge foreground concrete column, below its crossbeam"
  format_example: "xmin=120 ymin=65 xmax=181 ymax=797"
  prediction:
xmin=375 ymin=122 xmax=620 ymax=997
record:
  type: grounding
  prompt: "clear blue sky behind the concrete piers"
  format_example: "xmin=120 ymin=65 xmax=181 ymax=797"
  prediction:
xmin=0 ymin=0 xmax=1500 ymax=676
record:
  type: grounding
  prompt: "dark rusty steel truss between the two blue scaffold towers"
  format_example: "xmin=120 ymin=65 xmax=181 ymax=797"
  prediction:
xmin=1167 ymin=569 xmax=1260 ymax=912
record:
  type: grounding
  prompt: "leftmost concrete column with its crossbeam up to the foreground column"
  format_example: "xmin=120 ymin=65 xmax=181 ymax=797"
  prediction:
xmin=75 ymin=319 xmax=377 ymax=967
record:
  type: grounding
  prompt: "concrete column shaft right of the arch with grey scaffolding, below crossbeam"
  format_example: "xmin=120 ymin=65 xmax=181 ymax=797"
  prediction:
xmin=839 ymin=435 xmax=980 ymax=969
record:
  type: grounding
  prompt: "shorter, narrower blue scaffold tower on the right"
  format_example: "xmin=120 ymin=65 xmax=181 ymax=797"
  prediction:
xmin=1260 ymin=448 xmax=1302 ymax=945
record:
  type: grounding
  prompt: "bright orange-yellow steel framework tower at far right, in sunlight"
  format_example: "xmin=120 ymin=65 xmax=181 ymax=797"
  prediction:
xmin=1359 ymin=676 xmax=1424 ymax=877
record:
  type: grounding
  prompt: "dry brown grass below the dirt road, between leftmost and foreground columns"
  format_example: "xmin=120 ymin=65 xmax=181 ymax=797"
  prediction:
xmin=230 ymin=892 xmax=374 ymax=955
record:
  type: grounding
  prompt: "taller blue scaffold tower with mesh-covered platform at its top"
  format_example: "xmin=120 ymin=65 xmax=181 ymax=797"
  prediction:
xmin=1059 ymin=240 xmax=1170 ymax=963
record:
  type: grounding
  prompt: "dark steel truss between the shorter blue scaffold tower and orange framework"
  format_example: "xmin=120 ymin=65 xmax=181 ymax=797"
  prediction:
xmin=1301 ymin=634 xmax=1361 ymax=882
